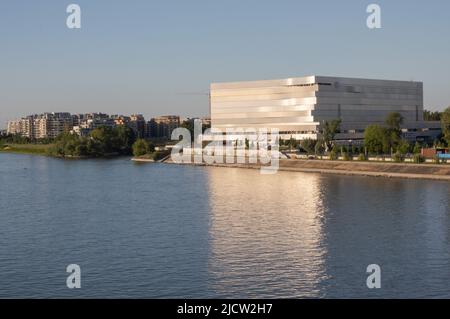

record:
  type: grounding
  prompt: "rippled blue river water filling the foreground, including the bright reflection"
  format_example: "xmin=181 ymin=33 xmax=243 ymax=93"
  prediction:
xmin=0 ymin=153 xmax=450 ymax=298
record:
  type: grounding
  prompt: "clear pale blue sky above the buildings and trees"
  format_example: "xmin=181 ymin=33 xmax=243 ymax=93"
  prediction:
xmin=0 ymin=0 xmax=450 ymax=127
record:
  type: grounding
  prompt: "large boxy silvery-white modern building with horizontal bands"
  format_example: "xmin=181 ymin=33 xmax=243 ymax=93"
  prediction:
xmin=211 ymin=76 xmax=440 ymax=140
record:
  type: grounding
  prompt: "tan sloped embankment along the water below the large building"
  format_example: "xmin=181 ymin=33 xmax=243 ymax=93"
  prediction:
xmin=164 ymin=159 xmax=450 ymax=181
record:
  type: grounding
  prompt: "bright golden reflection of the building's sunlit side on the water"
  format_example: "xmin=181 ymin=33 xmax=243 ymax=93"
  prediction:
xmin=208 ymin=168 xmax=327 ymax=298
